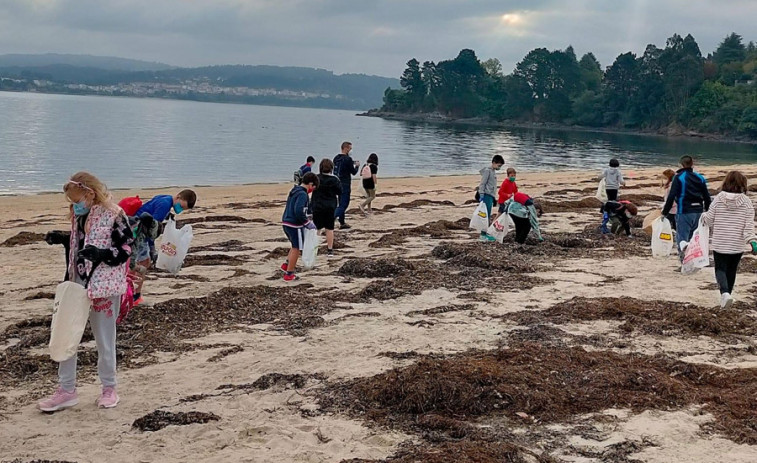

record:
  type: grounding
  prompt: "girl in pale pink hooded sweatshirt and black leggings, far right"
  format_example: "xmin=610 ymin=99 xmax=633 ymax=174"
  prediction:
xmin=702 ymin=170 xmax=757 ymax=309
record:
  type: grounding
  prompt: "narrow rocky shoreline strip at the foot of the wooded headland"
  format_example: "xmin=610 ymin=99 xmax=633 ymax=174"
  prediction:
xmin=356 ymin=109 xmax=757 ymax=145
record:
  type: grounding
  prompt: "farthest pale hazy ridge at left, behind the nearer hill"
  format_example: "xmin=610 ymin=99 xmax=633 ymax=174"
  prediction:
xmin=0 ymin=53 xmax=172 ymax=71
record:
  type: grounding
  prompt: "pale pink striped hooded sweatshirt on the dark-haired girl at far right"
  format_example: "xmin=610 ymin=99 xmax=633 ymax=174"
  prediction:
xmin=702 ymin=191 xmax=757 ymax=254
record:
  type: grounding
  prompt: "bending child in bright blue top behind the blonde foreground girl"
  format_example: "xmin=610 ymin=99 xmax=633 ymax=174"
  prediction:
xmin=131 ymin=190 xmax=197 ymax=305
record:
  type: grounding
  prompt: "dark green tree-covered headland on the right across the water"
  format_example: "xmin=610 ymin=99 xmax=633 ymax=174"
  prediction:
xmin=376 ymin=33 xmax=757 ymax=140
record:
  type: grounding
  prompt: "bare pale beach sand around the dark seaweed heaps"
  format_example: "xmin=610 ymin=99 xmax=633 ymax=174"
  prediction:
xmin=0 ymin=167 xmax=757 ymax=462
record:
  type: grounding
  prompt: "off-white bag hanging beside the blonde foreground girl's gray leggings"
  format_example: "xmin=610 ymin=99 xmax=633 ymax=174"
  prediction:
xmin=50 ymin=281 xmax=92 ymax=362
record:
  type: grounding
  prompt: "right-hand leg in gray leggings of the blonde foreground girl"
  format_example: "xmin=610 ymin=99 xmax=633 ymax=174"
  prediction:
xmin=89 ymin=296 xmax=121 ymax=387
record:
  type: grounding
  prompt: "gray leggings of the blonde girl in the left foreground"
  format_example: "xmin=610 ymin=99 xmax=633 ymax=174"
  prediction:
xmin=58 ymin=282 xmax=121 ymax=392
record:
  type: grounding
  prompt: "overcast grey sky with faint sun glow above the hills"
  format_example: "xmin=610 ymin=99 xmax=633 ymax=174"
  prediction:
xmin=0 ymin=0 xmax=757 ymax=77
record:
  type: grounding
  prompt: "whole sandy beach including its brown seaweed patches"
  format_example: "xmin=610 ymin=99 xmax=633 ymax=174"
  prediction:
xmin=0 ymin=166 xmax=757 ymax=463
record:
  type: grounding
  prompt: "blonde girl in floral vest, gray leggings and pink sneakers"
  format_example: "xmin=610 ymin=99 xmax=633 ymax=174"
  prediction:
xmin=38 ymin=172 xmax=131 ymax=412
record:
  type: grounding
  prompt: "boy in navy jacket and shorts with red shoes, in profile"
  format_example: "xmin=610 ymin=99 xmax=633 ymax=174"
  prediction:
xmin=281 ymin=172 xmax=318 ymax=281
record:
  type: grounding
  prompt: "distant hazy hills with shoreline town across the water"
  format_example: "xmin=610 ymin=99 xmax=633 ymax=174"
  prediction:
xmin=0 ymin=55 xmax=399 ymax=110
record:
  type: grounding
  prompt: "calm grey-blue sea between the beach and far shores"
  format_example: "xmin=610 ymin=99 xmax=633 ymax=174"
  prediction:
xmin=0 ymin=92 xmax=757 ymax=194
